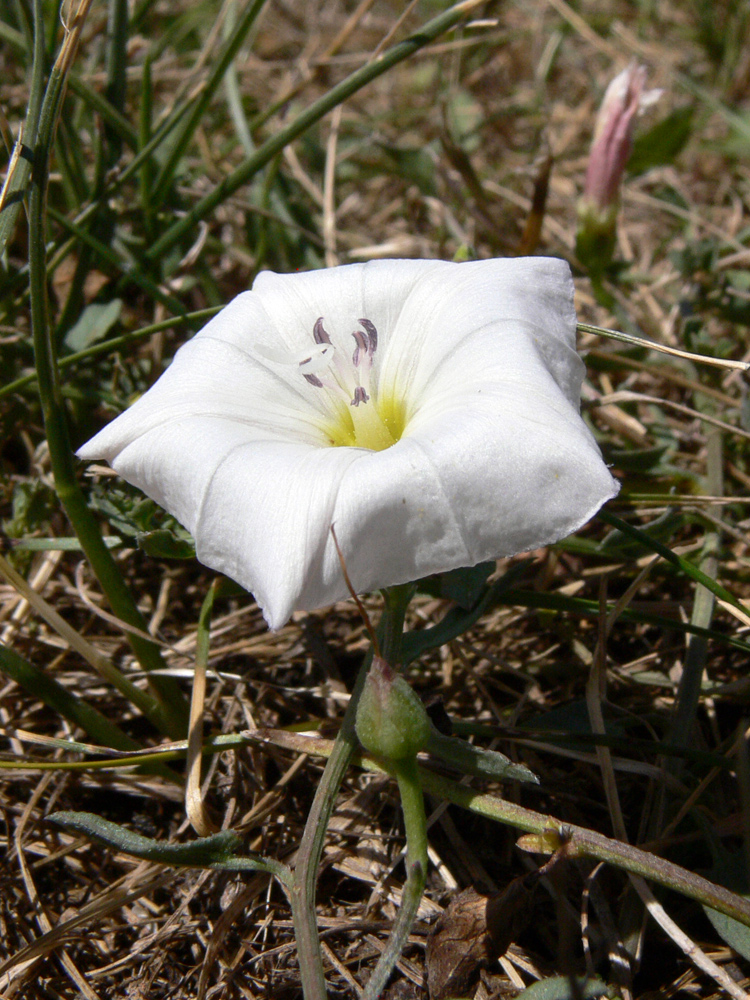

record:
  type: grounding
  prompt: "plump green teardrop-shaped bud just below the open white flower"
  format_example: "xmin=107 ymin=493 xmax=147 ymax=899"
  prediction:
xmin=356 ymin=656 xmax=432 ymax=761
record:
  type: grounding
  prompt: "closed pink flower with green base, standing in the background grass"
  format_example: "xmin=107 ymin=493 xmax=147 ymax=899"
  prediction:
xmin=576 ymin=63 xmax=661 ymax=272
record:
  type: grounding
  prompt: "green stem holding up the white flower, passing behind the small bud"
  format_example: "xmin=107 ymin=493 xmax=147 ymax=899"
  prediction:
xmin=290 ymin=587 xmax=414 ymax=1000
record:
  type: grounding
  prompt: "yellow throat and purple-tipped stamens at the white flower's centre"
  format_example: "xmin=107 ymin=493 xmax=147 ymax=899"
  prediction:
xmin=299 ymin=316 xmax=405 ymax=451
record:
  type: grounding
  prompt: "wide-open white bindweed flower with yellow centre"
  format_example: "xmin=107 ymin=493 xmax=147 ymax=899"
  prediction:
xmin=78 ymin=258 xmax=618 ymax=628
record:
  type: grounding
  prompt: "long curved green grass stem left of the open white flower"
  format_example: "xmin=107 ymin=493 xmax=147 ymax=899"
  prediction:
xmin=29 ymin=3 xmax=187 ymax=737
